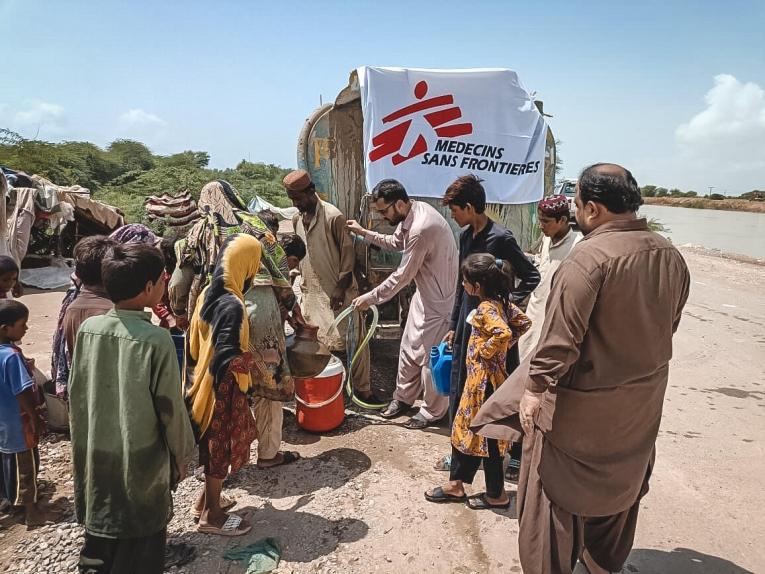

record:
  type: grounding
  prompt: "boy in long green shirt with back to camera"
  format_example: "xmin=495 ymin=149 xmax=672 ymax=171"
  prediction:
xmin=69 ymin=244 xmax=194 ymax=574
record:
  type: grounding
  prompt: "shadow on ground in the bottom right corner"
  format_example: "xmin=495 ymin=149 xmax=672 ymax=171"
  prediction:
xmin=622 ymin=548 xmax=754 ymax=574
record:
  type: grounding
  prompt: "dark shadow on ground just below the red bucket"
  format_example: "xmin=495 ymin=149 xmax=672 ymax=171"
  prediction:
xmin=226 ymin=448 xmax=372 ymax=499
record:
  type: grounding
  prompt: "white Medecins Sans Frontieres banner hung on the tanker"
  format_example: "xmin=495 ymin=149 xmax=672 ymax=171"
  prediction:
xmin=358 ymin=66 xmax=547 ymax=203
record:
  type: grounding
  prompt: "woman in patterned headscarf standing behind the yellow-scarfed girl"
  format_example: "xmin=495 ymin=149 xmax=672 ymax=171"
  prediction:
xmin=170 ymin=180 xmax=305 ymax=468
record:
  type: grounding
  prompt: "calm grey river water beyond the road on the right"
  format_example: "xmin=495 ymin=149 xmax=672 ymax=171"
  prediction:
xmin=640 ymin=205 xmax=765 ymax=259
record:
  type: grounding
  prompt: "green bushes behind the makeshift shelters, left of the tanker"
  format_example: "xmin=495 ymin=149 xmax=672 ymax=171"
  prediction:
xmin=0 ymin=129 xmax=290 ymax=221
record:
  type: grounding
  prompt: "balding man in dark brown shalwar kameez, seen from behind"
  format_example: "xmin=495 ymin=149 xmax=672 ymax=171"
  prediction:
xmin=473 ymin=164 xmax=690 ymax=574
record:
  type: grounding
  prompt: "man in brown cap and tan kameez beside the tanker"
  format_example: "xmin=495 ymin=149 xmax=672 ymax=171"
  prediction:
xmin=283 ymin=169 xmax=380 ymax=403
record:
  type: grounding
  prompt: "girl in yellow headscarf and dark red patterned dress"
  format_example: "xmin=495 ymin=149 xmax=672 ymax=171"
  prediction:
xmin=187 ymin=234 xmax=262 ymax=536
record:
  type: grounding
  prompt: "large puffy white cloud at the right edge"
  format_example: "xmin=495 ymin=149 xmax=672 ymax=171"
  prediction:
xmin=675 ymin=74 xmax=765 ymax=171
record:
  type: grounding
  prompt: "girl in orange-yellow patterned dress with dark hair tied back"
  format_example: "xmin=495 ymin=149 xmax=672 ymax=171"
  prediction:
xmin=425 ymin=253 xmax=531 ymax=510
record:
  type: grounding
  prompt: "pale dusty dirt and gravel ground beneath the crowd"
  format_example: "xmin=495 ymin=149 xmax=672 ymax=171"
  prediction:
xmin=0 ymin=245 xmax=765 ymax=574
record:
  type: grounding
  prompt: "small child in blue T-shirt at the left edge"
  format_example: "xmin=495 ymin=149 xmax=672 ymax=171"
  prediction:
xmin=0 ymin=299 xmax=48 ymax=526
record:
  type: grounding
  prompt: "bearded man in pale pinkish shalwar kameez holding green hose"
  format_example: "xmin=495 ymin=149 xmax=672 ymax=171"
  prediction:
xmin=348 ymin=179 xmax=457 ymax=429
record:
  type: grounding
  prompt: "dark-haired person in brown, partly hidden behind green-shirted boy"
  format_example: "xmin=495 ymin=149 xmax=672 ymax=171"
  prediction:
xmin=62 ymin=235 xmax=117 ymax=364
